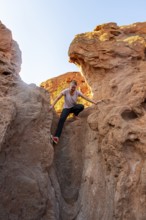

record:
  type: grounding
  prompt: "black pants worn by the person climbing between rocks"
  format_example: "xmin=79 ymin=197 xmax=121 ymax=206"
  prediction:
xmin=55 ymin=104 xmax=84 ymax=137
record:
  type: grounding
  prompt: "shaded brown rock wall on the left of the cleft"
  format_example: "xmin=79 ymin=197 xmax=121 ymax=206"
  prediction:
xmin=0 ymin=21 xmax=57 ymax=220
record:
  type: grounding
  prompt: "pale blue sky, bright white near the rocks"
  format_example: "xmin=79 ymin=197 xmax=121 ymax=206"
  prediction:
xmin=0 ymin=0 xmax=146 ymax=85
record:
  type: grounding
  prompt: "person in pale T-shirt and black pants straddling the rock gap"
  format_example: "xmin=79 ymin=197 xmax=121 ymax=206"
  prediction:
xmin=50 ymin=80 xmax=101 ymax=144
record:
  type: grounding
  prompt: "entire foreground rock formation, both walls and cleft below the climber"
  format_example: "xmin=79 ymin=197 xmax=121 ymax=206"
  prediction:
xmin=0 ymin=19 xmax=146 ymax=220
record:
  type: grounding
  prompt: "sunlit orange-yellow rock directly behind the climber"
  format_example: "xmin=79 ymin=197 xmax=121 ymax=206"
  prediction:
xmin=40 ymin=72 xmax=92 ymax=113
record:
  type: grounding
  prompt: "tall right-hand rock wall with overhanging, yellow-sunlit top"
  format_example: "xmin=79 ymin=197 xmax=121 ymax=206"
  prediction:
xmin=69 ymin=23 xmax=146 ymax=220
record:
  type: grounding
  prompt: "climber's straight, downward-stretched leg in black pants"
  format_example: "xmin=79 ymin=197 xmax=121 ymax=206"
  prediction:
xmin=55 ymin=108 xmax=70 ymax=138
